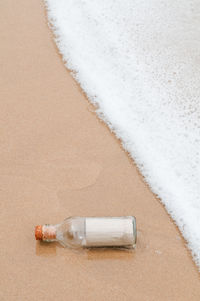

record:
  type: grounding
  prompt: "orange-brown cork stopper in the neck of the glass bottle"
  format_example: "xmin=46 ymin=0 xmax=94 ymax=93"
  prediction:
xmin=35 ymin=225 xmax=56 ymax=241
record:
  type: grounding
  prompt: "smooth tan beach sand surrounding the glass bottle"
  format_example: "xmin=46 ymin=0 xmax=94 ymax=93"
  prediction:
xmin=0 ymin=0 xmax=200 ymax=301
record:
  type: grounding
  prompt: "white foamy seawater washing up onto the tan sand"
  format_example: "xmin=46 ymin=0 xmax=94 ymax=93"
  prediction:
xmin=46 ymin=0 xmax=200 ymax=265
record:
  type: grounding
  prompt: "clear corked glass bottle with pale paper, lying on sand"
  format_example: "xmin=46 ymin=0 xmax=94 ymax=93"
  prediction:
xmin=35 ymin=216 xmax=137 ymax=248
